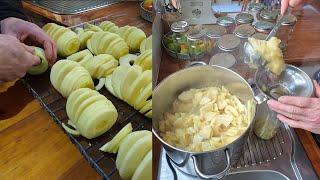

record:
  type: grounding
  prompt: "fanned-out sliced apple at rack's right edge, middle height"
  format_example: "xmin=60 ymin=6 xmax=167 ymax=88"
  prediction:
xmin=105 ymin=65 xmax=152 ymax=118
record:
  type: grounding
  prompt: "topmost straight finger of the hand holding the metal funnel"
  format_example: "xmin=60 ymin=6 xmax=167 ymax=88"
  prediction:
xmin=278 ymin=96 xmax=315 ymax=108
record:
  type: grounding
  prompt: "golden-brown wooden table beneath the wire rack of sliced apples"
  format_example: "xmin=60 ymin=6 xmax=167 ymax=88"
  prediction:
xmin=0 ymin=2 xmax=151 ymax=180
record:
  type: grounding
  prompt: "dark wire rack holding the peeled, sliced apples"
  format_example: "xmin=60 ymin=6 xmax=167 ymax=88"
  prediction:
xmin=22 ymin=15 xmax=152 ymax=179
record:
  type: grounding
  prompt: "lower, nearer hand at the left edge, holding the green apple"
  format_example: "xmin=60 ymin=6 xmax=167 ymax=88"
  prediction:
xmin=0 ymin=34 xmax=40 ymax=82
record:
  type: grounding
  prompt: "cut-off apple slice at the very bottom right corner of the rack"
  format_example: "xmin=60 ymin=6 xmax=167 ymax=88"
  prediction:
xmin=131 ymin=150 xmax=152 ymax=180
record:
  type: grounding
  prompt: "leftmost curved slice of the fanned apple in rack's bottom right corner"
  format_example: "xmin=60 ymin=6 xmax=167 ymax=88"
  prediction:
xmin=116 ymin=130 xmax=152 ymax=169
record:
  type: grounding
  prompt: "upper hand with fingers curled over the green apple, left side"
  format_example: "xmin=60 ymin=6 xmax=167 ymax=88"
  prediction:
xmin=1 ymin=18 xmax=57 ymax=65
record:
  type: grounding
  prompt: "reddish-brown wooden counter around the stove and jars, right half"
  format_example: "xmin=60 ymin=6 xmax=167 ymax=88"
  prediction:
xmin=153 ymin=0 xmax=320 ymax=177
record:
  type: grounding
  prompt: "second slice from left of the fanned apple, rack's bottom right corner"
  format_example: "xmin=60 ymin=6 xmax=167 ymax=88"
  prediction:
xmin=118 ymin=133 xmax=152 ymax=179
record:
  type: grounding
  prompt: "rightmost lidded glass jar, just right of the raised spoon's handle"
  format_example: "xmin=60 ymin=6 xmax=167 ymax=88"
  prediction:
xmin=276 ymin=14 xmax=297 ymax=51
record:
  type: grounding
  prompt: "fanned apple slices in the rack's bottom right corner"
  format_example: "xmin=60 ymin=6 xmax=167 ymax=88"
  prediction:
xmin=100 ymin=123 xmax=152 ymax=180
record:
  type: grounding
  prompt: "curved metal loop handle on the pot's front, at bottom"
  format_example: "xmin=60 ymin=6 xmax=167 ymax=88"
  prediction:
xmin=191 ymin=149 xmax=230 ymax=179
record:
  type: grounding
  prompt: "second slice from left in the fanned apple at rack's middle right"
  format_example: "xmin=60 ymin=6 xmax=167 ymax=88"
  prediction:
xmin=121 ymin=65 xmax=142 ymax=102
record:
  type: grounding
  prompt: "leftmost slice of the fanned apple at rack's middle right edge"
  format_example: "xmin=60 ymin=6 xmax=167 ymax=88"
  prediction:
xmin=111 ymin=66 xmax=130 ymax=99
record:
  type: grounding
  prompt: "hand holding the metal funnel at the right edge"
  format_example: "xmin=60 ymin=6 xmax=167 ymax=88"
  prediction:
xmin=268 ymin=81 xmax=320 ymax=134
